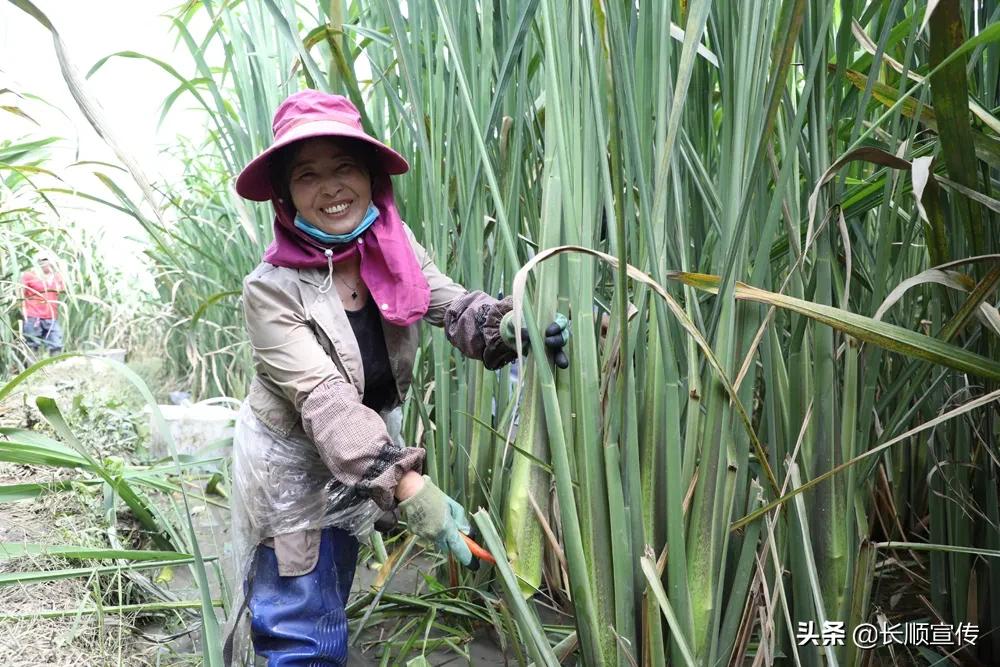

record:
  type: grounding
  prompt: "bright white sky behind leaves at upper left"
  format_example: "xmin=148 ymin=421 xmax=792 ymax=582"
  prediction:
xmin=0 ymin=0 xmax=213 ymax=282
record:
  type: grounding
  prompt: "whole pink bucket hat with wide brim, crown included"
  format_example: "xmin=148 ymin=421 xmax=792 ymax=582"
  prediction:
xmin=236 ymin=90 xmax=410 ymax=201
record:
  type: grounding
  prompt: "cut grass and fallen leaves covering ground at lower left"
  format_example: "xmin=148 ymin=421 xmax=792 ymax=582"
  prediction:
xmin=0 ymin=358 xmax=225 ymax=665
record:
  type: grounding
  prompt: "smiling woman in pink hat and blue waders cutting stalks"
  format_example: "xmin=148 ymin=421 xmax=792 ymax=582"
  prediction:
xmin=227 ymin=90 xmax=568 ymax=667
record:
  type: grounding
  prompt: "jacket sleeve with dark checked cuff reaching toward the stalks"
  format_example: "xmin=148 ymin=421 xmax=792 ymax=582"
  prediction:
xmin=406 ymin=227 xmax=517 ymax=370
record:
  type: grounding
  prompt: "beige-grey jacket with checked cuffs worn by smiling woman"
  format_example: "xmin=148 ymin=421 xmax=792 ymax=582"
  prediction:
xmin=243 ymin=228 xmax=515 ymax=576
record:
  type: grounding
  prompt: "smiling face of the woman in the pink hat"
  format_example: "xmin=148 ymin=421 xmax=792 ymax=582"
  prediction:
xmin=288 ymin=137 xmax=372 ymax=234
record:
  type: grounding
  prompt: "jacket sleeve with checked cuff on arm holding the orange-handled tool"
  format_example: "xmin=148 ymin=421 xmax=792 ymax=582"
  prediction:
xmin=243 ymin=277 xmax=424 ymax=509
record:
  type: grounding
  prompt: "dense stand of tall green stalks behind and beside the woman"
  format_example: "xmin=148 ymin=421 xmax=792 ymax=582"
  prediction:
xmin=17 ymin=0 xmax=1000 ymax=665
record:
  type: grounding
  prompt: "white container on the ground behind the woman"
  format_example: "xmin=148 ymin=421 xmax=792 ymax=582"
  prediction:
xmin=144 ymin=398 xmax=239 ymax=458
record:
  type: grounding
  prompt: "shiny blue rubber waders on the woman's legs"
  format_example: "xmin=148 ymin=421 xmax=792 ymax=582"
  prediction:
xmin=248 ymin=528 xmax=358 ymax=667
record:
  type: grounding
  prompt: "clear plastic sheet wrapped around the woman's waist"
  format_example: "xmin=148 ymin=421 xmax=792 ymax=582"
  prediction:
xmin=226 ymin=402 xmax=402 ymax=665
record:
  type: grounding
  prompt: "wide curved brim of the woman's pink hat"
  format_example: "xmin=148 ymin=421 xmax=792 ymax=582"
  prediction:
xmin=236 ymin=120 xmax=410 ymax=201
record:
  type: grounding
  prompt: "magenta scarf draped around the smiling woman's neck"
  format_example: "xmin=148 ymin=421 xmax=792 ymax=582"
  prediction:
xmin=264 ymin=175 xmax=431 ymax=326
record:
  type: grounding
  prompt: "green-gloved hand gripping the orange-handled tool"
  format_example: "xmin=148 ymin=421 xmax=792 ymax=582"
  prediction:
xmin=399 ymin=475 xmax=472 ymax=566
